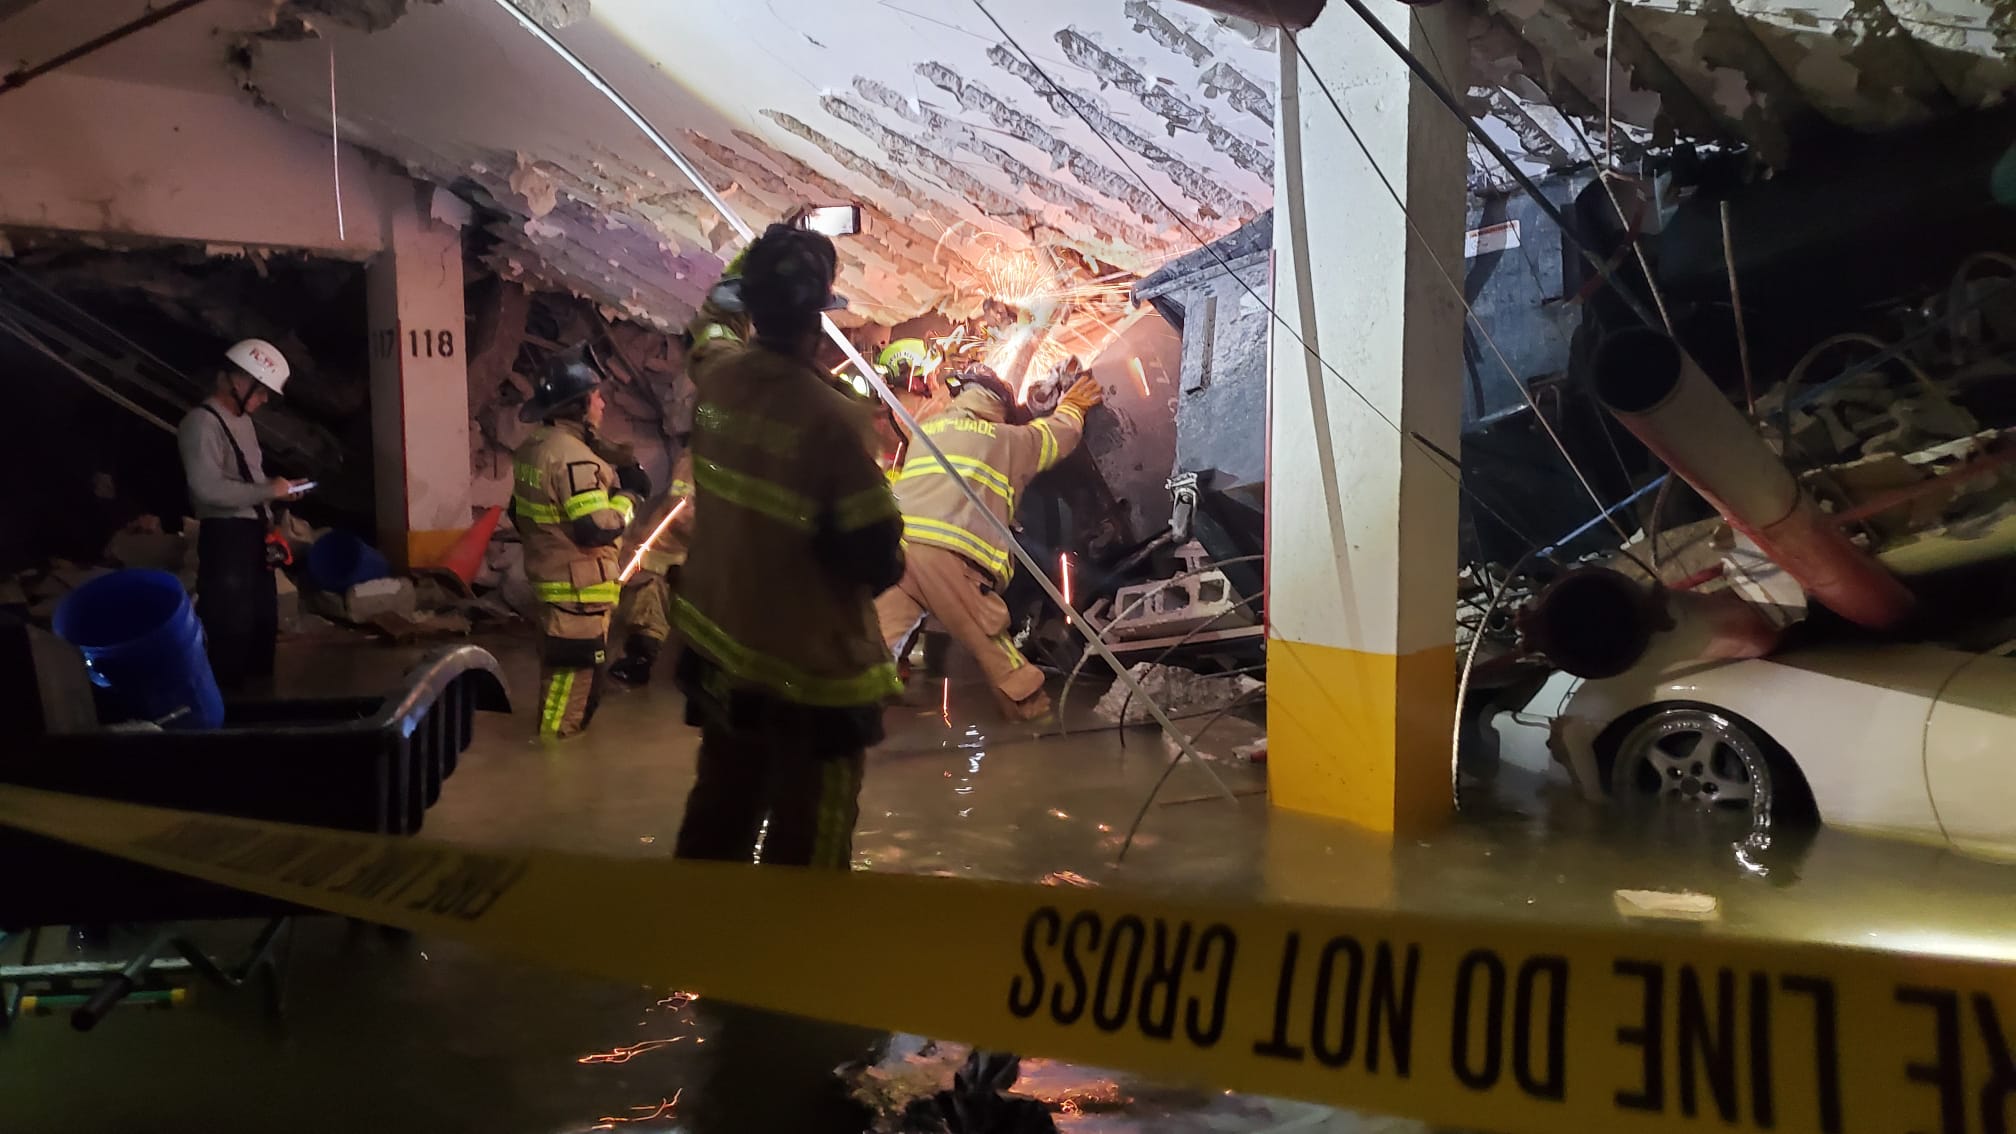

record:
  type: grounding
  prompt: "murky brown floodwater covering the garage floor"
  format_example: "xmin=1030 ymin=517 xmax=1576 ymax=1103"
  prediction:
xmin=0 ymin=625 xmax=2016 ymax=1134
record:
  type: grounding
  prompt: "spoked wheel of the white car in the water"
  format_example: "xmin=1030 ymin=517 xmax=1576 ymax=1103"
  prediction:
xmin=1609 ymin=704 xmax=1804 ymax=835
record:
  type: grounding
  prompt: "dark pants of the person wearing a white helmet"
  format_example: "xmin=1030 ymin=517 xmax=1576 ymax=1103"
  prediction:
xmin=196 ymin=519 xmax=280 ymax=690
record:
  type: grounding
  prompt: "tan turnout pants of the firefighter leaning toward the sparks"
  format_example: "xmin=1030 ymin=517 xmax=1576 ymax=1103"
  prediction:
xmin=875 ymin=543 xmax=1050 ymax=720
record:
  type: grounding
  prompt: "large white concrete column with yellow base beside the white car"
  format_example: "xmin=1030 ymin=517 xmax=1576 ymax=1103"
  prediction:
xmin=1266 ymin=4 xmax=1466 ymax=833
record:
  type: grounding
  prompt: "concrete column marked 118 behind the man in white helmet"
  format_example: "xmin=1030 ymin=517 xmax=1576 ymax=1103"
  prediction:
xmin=365 ymin=182 xmax=470 ymax=569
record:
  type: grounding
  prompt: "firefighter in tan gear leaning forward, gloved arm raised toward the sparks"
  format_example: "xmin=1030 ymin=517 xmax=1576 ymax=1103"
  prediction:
xmin=875 ymin=365 xmax=1105 ymax=720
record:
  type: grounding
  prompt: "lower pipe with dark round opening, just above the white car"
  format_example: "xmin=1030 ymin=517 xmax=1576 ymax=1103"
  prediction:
xmin=1518 ymin=567 xmax=1780 ymax=678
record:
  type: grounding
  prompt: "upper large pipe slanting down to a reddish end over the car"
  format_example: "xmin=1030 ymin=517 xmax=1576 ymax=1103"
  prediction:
xmin=1595 ymin=329 xmax=1915 ymax=630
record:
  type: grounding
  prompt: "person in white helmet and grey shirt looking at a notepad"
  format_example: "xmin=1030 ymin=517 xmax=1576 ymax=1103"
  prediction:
xmin=175 ymin=339 xmax=296 ymax=690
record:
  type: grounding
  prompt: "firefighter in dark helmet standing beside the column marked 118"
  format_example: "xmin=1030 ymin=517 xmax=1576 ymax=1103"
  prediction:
xmin=510 ymin=355 xmax=635 ymax=739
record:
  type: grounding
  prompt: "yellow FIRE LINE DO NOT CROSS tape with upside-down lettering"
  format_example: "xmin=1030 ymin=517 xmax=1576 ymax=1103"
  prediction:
xmin=0 ymin=787 xmax=2016 ymax=1134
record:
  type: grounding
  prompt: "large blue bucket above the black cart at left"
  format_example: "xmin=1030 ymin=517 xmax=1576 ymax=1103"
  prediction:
xmin=54 ymin=569 xmax=224 ymax=728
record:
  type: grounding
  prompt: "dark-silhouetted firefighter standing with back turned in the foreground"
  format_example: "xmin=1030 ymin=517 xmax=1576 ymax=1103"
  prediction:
xmin=671 ymin=224 xmax=903 ymax=870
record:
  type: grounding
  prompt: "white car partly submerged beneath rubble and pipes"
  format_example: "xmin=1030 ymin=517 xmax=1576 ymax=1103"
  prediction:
xmin=1548 ymin=644 xmax=2016 ymax=860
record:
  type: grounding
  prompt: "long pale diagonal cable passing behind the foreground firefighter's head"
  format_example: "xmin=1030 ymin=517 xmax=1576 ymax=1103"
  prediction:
xmin=496 ymin=0 xmax=1238 ymax=807
